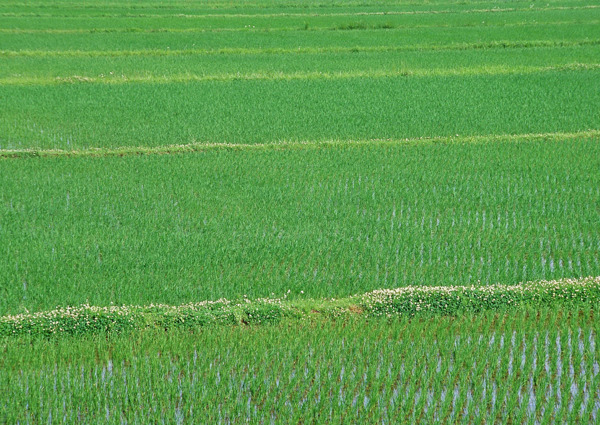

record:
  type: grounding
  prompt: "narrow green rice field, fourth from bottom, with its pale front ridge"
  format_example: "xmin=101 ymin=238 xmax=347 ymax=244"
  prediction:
xmin=0 ymin=45 xmax=600 ymax=85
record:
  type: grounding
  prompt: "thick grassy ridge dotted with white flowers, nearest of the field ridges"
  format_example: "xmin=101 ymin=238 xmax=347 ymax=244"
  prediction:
xmin=0 ymin=276 xmax=600 ymax=337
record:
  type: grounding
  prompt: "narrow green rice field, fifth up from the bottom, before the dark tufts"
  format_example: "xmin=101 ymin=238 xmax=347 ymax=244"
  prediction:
xmin=2 ymin=10 xmax=597 ymax=52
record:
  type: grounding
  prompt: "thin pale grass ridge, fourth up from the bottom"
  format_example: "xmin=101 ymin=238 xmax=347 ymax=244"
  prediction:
xmin=0 ymin=39 xmax=600 ymax=57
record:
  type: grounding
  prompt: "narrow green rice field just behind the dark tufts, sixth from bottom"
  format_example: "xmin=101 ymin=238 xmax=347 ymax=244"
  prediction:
xmin=0 ymin=6 xmax=600 ymax=34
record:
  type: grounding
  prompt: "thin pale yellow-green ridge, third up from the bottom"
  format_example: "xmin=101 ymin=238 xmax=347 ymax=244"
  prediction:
xmin=0 ymin=63 xmax=600 ymax=86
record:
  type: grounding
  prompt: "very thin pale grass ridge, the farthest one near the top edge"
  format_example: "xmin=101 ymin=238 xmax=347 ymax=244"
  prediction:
xmin=0 ymin=5 xmax=600 ymax=18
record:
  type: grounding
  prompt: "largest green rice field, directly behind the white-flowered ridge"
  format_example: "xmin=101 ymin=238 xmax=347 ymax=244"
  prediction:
xmin=0 ymin=137 xmax=600 ymax=314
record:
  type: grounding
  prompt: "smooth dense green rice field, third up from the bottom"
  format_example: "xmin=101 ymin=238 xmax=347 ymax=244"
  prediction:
xmin=0 ymin=70 xmax=600 ymax=149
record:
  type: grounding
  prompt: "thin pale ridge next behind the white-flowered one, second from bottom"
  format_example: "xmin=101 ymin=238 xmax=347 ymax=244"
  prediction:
xmin=0 ymin=129 xmax=600 ymax=159
